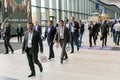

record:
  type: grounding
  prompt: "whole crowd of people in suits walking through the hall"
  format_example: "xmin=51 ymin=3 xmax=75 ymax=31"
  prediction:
xmin=2 ymin=17 xmax=120 ymax=77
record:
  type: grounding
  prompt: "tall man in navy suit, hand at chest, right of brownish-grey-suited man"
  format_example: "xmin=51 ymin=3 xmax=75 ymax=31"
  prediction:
xmin=69 ymin=17 xmax=79 ymax=53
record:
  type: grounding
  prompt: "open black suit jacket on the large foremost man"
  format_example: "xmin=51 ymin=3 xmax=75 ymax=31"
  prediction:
xmin=22 ymin=30 xmax=43 ymax=53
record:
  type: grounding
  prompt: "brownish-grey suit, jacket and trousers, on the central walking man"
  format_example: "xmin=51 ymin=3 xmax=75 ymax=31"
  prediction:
xmin=55 ymin=27 xmax=70 ymax=63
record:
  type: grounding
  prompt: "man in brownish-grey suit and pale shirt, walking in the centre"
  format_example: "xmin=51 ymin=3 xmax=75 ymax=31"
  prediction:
xmin=55 ymin=20 xmax=70 ymax=64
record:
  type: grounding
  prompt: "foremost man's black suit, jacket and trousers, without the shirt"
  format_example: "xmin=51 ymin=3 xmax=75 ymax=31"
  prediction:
xmin=22 ymin=30 xmax=43 ymax=74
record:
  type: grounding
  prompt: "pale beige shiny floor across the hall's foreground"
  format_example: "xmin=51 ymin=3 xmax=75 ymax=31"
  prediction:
xmin=0 ymin=32 xmax=120 ymax=80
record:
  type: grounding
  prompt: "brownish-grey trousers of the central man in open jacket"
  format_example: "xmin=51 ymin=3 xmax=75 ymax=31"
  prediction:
xmin=60 ymin=39 xmax=68 ymax=61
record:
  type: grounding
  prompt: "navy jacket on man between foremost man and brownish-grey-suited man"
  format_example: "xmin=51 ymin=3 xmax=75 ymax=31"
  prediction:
xmin=45 ymin=26 xmax=56 ymax=42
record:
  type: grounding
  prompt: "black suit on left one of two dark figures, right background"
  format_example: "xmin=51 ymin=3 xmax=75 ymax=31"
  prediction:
xmin=88 ymin=25 xmax=97 ymax=47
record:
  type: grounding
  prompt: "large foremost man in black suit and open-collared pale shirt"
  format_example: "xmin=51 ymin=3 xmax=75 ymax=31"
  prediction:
xmin=22 ymin=22 xmax=43 ymax=77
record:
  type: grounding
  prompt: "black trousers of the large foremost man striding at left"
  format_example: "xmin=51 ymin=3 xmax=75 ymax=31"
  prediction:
xmin=26 ymin=48 xmax=42 ymax=74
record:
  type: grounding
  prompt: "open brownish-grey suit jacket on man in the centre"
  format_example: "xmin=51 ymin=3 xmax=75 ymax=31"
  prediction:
xmin=55 ymin=27 xmax=70 ymax=43
